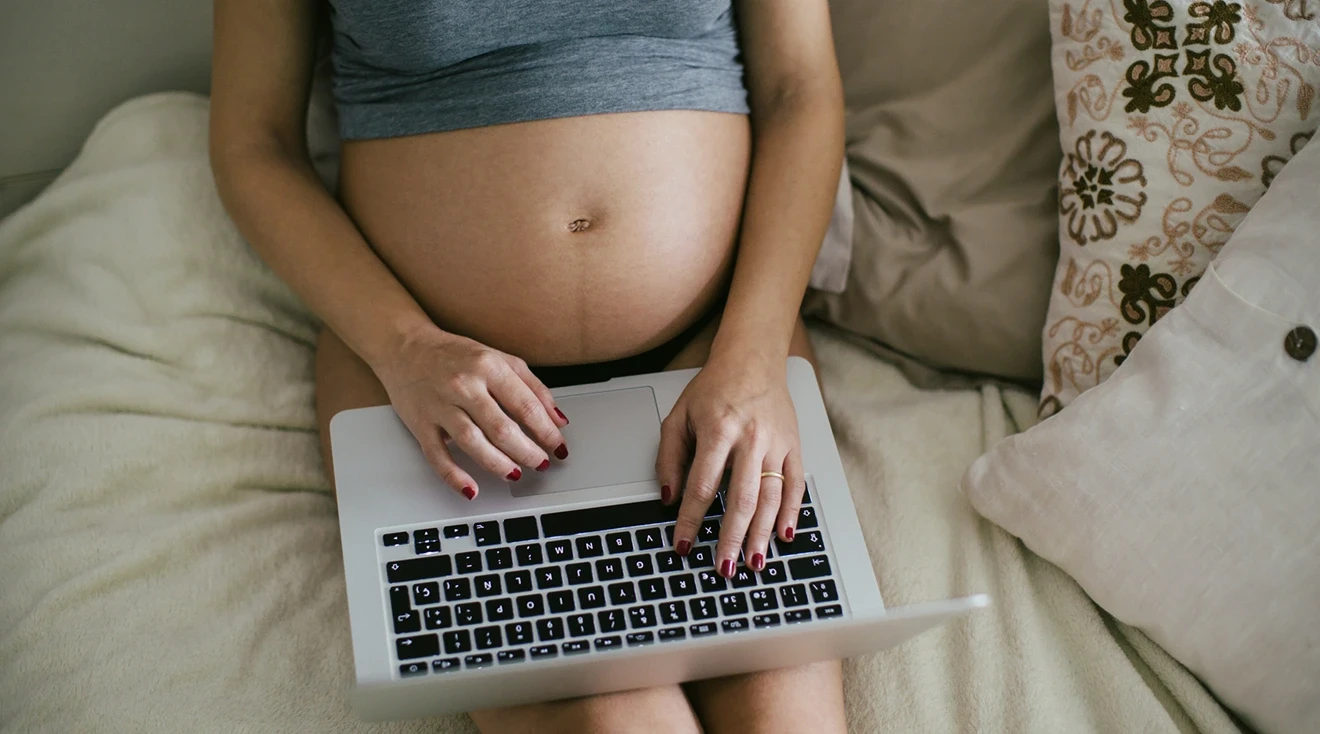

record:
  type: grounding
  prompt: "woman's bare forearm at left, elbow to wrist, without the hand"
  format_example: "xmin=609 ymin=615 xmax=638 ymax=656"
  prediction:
xmin=213 ymin=144 xmax=432 ymax=371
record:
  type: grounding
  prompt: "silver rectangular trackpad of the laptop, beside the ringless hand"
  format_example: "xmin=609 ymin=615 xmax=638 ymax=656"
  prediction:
xmin=508 ymin=387 xmax=660 ymax=496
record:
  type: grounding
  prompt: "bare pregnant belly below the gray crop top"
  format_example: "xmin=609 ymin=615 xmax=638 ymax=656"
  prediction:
xmin=339 ymin=111 xmax=751 ymax=364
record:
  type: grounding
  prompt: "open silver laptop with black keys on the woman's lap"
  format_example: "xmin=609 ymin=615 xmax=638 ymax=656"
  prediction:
xmin=330 ymin=358 xmax=989 ymax=721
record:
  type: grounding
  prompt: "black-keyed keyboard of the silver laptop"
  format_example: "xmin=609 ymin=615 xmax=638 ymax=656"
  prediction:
xmin=378 ymin=485 xmax=845 ymax=677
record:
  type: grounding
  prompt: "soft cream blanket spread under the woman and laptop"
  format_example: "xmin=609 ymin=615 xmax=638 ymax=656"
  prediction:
xmin=0 ymin=95 xmax=1236 ymax=734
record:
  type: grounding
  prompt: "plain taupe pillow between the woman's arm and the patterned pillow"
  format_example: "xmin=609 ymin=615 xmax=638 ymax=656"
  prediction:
xmin=805 ymin=0 xmax=1059 ymax=380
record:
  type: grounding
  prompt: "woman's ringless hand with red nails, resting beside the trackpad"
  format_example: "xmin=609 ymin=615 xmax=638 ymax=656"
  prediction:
xmin=374 ymin=327 xmax=569 ymax=499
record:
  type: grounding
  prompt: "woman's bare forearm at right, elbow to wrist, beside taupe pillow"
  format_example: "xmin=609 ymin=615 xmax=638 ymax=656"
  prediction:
xmin=711 ymin=88 xmax=843 ymax=363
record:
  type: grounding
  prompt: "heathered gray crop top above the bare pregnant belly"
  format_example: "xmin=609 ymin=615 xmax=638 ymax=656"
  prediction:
xmin=330 ymin=0 xmax=747 ymax=139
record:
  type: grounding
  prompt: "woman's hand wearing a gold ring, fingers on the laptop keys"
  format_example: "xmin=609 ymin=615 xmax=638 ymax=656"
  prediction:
xmin=656 ymin=355 xmax=805 ymax=578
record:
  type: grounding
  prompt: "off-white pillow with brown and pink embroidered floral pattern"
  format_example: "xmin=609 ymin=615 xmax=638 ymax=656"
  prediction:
xmin=1040 ymin=0 xmax=1320 ymax=416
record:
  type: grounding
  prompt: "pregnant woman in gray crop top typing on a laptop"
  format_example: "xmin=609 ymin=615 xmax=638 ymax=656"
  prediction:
xmin=211 ymin=0 xmax=845 ymax=733
